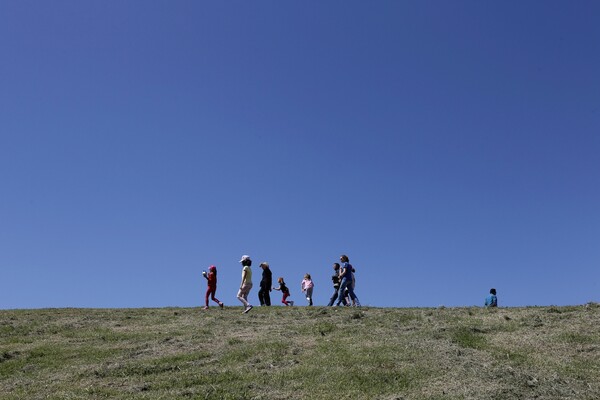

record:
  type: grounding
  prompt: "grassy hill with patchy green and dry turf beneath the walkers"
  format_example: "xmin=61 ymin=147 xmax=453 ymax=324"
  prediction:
xmin=0 ymin=304 xmax=600 ymax=400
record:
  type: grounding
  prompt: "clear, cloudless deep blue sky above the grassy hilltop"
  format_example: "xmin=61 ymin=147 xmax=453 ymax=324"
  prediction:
xmin=0 ymin=1 xmax=600 ymax=309
